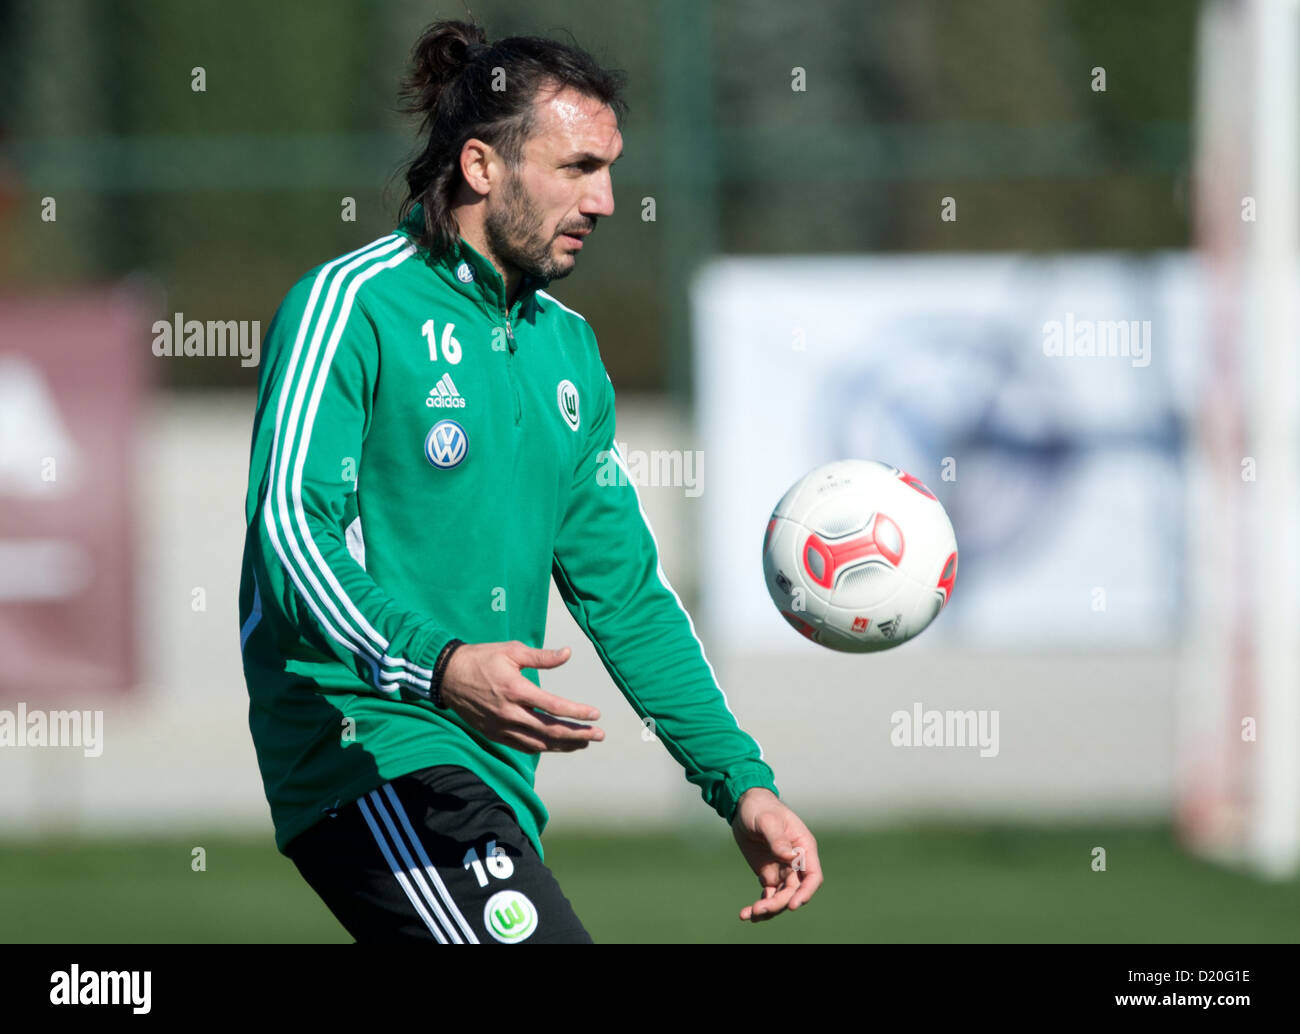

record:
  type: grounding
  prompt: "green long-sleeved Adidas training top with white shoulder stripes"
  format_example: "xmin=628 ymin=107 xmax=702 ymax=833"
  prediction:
xmin=239 ymin=207 xmax=776 ymax=855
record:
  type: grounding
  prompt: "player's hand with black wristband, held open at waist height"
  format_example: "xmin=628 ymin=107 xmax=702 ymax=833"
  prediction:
xmin=442 ymin=641 xmax=605 ymax=754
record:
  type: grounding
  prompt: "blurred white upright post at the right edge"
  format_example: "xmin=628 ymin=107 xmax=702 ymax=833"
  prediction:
xmin=1242 ymin=0 xmax=1300 ymax=878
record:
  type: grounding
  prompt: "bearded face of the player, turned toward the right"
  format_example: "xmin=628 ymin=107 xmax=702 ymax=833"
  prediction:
xmin=484 ymin=90 xmax=623 ymax=280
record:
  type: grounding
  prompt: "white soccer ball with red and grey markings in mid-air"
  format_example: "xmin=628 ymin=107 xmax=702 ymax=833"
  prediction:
xmin=763 ymin=459 xmax=957 ymax=653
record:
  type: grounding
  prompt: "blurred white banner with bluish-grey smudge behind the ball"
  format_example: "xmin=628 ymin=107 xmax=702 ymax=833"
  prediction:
xmin=693 ymin=254 xmax=1204 ymax=652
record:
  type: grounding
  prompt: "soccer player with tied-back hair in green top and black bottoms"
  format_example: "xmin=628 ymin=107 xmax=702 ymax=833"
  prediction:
xmin=239 ymin=22 xmax=822 ymax=944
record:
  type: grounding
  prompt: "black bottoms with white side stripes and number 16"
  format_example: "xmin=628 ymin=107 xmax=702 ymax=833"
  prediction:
xmin=286 ymin=765 xmax=592 ymax=944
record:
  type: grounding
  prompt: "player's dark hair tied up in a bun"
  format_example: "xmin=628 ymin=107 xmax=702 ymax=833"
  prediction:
xmin=400 ymin=21 xmax=627 ymax=255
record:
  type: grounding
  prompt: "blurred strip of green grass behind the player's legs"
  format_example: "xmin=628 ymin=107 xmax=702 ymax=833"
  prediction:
xmin=0 ymin=829 xmax=1300 ymax=943
